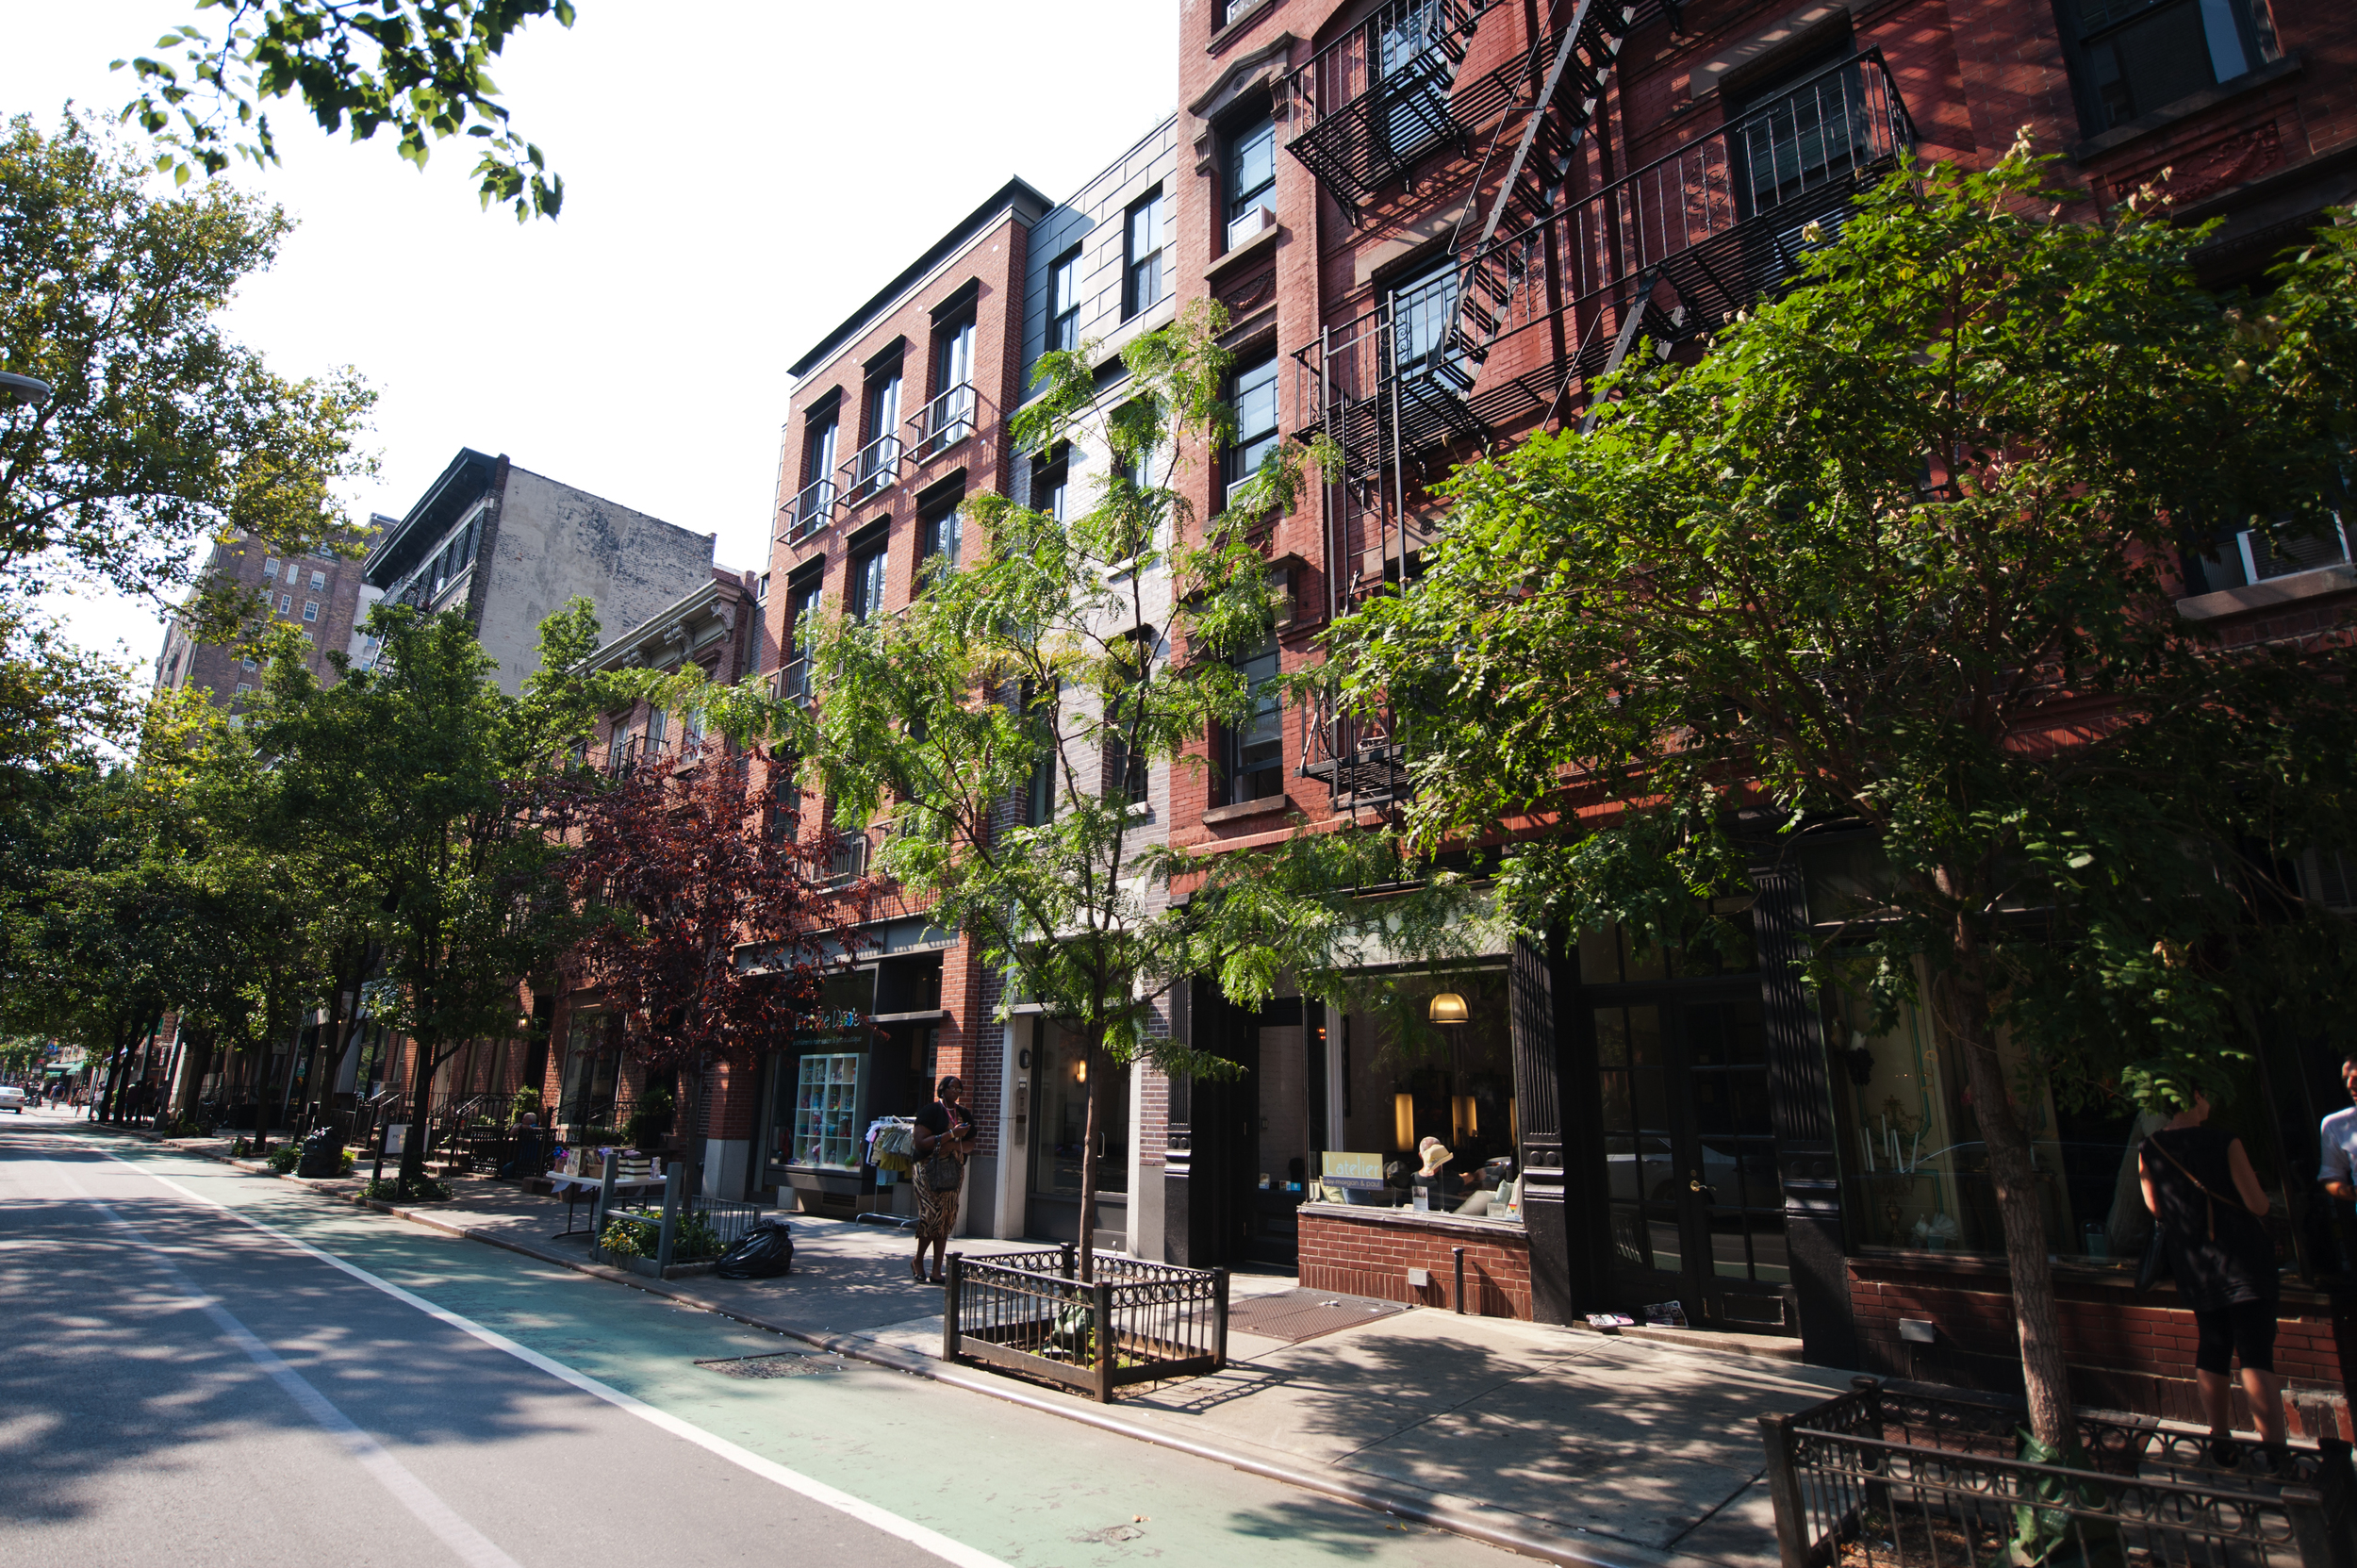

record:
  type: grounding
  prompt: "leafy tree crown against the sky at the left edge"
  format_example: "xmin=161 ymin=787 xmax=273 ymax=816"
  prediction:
xmin=0 ymin=116 xmax=375 ymax=641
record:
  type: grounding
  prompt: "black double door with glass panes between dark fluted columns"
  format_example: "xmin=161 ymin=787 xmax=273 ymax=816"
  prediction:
xmin=1587 ymin=979 xmax=1791 ymax=1332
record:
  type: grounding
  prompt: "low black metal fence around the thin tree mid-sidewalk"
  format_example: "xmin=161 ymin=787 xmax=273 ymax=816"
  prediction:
xmin=941 ymin=1243 xmax=1228 ymax=1405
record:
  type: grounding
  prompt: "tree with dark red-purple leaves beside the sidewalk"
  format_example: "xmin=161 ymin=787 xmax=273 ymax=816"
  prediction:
xmin=559 ymin=745 xmax=865 ymax=1183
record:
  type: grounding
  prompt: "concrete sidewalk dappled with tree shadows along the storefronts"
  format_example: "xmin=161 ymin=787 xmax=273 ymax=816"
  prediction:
xmin=114 ymin=1139 xmax=1848 ymax=1568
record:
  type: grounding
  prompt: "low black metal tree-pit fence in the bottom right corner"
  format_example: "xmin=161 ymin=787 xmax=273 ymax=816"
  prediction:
xmin=1761 ymin=1377 xmax=2357 ymax=1568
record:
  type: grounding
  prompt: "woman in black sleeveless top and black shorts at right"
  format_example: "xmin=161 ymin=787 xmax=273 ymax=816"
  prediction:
xmin=2135 ymin=1094 xmax=2284 ymax=1464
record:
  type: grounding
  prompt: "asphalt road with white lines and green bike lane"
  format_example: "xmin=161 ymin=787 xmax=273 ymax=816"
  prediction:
xmin=0 ymin=1113 xmax=1521 ymax=1568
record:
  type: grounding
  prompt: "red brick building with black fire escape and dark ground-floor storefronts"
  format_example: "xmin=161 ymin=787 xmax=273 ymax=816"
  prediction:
xmin=1148 ymin=0 xmax=2357 ymax=1427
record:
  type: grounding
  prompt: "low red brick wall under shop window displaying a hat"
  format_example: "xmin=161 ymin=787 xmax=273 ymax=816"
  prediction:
xmin=1301 ymin=1202 xmax=1530 ymax=1320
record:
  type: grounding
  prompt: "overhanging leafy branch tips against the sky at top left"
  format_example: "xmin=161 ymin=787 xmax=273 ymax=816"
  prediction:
xmin=113 ymin=0 xmax=573 ymax=222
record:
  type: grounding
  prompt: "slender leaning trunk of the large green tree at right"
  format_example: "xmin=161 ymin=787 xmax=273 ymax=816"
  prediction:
xmin=1936 ymin=910 xmax=2074 ymax=1452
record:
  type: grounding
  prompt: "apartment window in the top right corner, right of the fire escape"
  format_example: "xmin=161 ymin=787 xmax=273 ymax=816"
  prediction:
xmin=2063 ymin=0 xmax=2266 ymax=132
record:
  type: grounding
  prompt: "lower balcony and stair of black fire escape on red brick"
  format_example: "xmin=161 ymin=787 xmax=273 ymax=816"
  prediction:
xmin=1294 ymin=24 xmax=1914 ymax=806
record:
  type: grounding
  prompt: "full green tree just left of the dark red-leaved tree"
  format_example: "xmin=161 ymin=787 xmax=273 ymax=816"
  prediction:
xmin=255 ymin=599 xmax=602 ymax=1191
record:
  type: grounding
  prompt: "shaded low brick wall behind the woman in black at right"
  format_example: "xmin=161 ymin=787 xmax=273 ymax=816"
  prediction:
xmin=1851 ymin=1257 xmax=2357 ymax=1438
